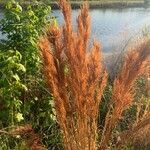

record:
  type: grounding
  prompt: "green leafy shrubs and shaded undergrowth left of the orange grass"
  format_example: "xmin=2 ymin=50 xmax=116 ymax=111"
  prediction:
xmin=0 ymin=0 xmax=61 ymax=150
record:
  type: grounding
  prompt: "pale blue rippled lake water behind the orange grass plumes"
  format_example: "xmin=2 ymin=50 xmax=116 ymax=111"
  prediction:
xmin=0 ymin=8 xmax=150 ymax=53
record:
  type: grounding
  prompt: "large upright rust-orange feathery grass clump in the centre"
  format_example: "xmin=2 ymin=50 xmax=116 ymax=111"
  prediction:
xmin=39 ymin=0 xmax=107 ymax=150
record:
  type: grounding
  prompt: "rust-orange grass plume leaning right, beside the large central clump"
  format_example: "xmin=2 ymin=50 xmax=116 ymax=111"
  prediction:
xmin=100 ymin=39 xmax=150 ymax=150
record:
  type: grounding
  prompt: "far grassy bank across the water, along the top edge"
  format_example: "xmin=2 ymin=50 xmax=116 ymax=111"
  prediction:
xmin=0 ymin=0 xmax=144 ymax=9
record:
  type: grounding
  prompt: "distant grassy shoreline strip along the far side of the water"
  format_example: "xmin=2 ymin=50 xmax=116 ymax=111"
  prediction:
xmin=0 ymin=1 xmax=150 ymax=10
